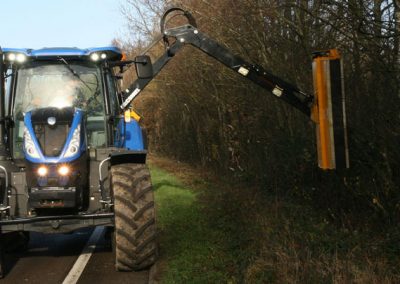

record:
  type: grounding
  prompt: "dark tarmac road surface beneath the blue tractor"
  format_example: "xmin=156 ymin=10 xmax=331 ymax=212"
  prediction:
xmin=0 ymin=228 xmax=149 ymax=284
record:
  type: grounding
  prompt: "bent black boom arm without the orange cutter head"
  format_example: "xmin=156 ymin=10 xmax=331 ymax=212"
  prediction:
xmin=121 ymin=24 xmax=313 ymax=116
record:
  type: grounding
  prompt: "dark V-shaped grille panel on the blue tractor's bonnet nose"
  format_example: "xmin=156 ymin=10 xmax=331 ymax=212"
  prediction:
xmin=34 ymin=123 xmax=70 ymax=157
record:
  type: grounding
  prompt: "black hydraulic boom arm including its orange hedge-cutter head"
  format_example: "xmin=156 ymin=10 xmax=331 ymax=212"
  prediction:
xmin=121 ymin=7 xmax=349 ymax=169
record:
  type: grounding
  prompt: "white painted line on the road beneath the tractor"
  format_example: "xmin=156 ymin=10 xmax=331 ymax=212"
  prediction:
xmin=63 ymin=227 xmax=104 ymax=284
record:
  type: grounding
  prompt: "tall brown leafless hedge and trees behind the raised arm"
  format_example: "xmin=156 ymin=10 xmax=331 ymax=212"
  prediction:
xmin=121 ymin=0 xmax=400 ymax=228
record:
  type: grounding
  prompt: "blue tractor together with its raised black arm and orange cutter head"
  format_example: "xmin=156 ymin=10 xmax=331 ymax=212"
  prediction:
xmin=0 ymin=8 xmax=348 ymax=275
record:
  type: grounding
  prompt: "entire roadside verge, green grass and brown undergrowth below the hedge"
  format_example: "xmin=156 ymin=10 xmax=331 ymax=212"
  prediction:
xmin=151 ymin=156 xmax=400 ymax=283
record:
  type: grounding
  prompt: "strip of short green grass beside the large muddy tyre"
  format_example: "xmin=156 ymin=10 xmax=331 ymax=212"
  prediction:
xmin=151 ymin=166 xmax=233 ymax=283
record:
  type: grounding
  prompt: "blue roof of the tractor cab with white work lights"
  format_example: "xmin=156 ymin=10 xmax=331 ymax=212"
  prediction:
xmin=2 ymin=46 xmax=123 ymax=61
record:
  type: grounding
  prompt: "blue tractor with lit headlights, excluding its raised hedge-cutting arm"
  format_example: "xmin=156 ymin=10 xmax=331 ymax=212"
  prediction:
xmin=0 ymin=47 xmax=157 ymax=276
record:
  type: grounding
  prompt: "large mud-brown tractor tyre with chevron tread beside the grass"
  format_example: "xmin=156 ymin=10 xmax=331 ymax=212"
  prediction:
xmin=111 ymin=164 xmax=157 ymax=271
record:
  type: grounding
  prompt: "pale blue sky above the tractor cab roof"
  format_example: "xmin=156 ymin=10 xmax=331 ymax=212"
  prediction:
xmin=0 ymin=0 xmax=125 ymax=48
